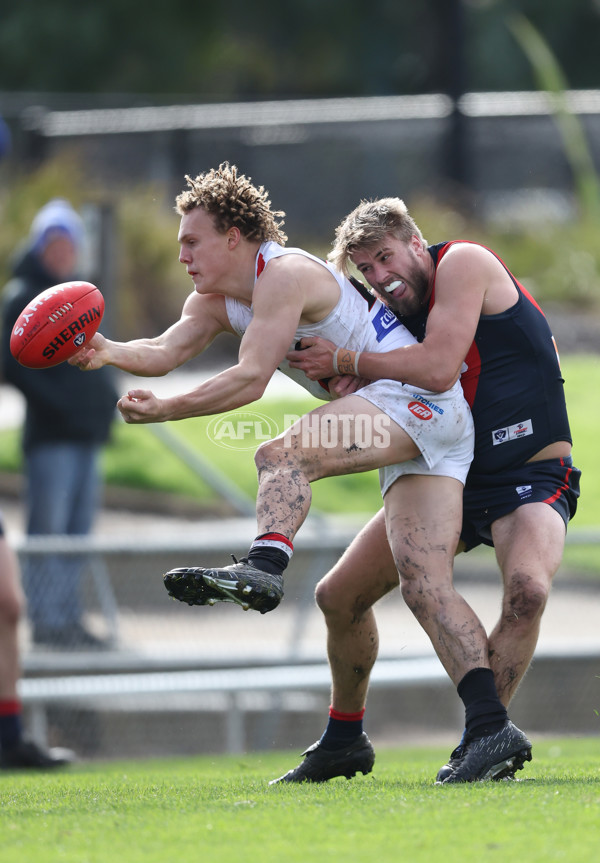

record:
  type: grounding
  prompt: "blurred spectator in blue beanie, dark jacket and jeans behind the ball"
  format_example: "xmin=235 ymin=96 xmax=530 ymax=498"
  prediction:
xmin=2 ymin=198 xmax=117 ymax=649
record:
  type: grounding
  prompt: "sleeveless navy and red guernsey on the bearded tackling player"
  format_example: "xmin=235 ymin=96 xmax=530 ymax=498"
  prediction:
xmin=398 ymin=240 xmax=572 ymax=475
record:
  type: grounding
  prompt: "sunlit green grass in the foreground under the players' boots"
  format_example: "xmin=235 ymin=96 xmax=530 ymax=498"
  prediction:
xmin=0 ymin=738 xmax=600 ymax=863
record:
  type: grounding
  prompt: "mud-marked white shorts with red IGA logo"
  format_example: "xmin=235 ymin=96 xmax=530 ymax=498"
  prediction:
xmin=354 ymin=380 xmax=474 ymax=495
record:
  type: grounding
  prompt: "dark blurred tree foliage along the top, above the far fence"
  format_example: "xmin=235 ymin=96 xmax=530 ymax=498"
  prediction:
xmin=0 ymin=0 xmax=600 ymax=101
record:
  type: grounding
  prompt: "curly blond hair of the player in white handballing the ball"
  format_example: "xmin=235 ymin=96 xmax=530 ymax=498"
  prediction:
xmin=175 ymin=162 xmax=287 ymax=246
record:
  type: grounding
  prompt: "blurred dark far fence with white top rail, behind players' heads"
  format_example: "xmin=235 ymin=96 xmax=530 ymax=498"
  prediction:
xmin=10 ymin=90 xmax=600 ymax=240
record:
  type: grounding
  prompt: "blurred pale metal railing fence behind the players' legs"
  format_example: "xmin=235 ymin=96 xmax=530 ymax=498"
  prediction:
xmin=16 ymin=519 xmax=600 ymax=758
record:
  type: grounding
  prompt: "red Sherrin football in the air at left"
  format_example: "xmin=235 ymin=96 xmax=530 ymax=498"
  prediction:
xmin=10 ymin=282 xmax=104 ymax=369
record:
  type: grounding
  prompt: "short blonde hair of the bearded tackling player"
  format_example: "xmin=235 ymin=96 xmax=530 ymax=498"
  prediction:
xmin=328 ymin=198 xmax=426 ymax=275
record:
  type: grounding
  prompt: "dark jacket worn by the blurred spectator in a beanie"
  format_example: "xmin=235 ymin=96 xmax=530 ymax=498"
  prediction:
xmin=2 ymin=246 xmax=117 ymax=452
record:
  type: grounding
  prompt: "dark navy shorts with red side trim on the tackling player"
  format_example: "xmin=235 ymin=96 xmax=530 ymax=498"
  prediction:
xmin=460 ymin=457 xmax=581 ymax=551
